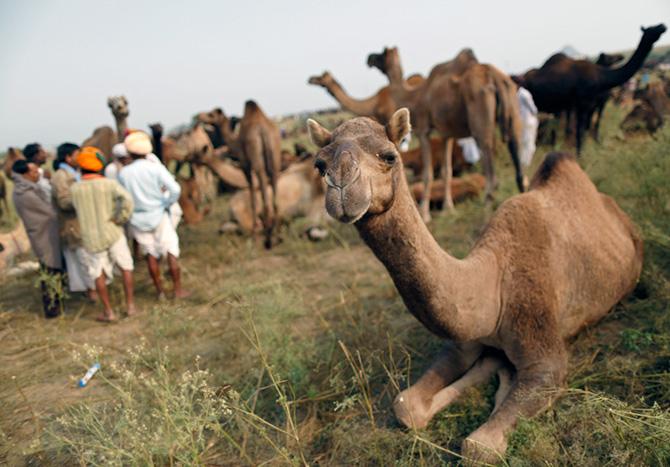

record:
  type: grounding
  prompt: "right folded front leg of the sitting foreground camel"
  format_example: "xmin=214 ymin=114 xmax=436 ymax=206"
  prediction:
xmin=461 ymin=349 xmax=567 ymax=464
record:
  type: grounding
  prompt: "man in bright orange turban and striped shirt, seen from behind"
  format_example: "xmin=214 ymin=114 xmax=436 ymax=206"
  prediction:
xmin=70 ymin=146 xmax=136 ymax=322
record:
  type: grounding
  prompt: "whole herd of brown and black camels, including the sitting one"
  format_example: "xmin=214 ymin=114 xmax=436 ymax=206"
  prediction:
xmin=1 ymin=24 xmax=668 ymax=463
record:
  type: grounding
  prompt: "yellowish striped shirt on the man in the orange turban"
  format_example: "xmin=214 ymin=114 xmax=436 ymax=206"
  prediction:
xmin=70 ymin=175 xmax=133 ymax=253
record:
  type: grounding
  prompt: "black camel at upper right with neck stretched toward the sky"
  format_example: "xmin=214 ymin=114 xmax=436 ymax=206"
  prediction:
xmin=521 ymin=24 xmax=666 ymax=154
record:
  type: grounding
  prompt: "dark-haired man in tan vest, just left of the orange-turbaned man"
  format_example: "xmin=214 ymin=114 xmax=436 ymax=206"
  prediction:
xmin=51 ymin=143 xmax=96 ymax=299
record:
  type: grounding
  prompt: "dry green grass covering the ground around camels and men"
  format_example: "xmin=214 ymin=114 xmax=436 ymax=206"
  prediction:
xmin=0 ymin=108 xmax=670 ymax=466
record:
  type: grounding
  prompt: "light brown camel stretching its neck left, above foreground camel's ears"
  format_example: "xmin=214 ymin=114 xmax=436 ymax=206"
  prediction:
xmin=307 ymin=71 xmax=423 ymax=125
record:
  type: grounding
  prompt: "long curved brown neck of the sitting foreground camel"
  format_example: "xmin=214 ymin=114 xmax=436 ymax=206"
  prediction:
xmin=356 ymin=172 xmax=496 ymax=339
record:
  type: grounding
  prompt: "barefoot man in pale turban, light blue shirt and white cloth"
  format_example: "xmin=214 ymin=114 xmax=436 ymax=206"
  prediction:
xmin=119 ymin=131 xmax=189 ymax=298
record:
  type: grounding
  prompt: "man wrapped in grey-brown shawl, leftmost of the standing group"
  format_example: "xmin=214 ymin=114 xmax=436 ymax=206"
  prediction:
xmin=12 ymin=159 xmax=63 ymax=318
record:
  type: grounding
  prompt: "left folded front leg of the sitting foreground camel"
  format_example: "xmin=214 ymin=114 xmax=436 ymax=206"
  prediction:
xmin=393 ymin=342 xmax=483 ymax=428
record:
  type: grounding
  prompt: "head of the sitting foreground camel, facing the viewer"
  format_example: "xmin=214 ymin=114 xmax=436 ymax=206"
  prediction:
xmin=307 ymin=108 xmax=410 ymax=224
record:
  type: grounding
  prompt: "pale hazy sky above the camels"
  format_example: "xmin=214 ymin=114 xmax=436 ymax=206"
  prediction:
xmin=0 ymin=0 xmax=670 ymax=150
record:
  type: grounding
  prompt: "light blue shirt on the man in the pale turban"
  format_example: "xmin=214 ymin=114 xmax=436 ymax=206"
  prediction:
xmin=119 ymin=159 xmax=181 ymax=231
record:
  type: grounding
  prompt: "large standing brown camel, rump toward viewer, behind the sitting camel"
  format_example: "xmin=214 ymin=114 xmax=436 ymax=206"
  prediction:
xmin=368 ymin=47 xmax=524 ymax=222
